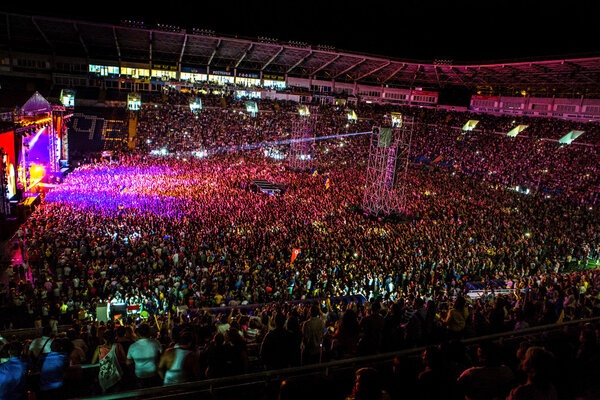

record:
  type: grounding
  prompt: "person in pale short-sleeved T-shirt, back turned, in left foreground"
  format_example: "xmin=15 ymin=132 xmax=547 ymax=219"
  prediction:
xmin=127 ymin=323 xmax=161 ymax=388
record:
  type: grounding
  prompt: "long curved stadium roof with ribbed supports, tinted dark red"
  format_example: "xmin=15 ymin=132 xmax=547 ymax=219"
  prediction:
xmin=0 ymin=13 xmax=600 ymax=92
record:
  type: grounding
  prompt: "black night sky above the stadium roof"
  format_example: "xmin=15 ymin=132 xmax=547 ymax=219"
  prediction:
xmin=0 ymin=0 xmax=600 ymax=63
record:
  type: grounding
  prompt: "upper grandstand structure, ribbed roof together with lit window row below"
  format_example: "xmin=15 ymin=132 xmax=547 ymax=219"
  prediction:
xmin=0 ymin=13 xmax=600 ymax=112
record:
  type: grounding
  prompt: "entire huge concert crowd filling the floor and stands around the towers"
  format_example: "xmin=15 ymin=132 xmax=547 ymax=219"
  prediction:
xmin=0 ymin=89 xmax=600 ymax=399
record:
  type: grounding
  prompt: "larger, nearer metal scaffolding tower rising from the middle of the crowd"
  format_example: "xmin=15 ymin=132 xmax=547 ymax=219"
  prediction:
xmin=362 ymin=117 xmax=414 ymax=216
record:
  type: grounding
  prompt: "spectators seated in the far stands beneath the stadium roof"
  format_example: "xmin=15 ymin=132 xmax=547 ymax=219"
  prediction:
xmin=138 ymin=92 xmax=600 ymax=203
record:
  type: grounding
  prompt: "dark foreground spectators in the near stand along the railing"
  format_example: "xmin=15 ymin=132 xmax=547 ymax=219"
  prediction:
xmin=0 ymin=296 xmax=600 ymax=400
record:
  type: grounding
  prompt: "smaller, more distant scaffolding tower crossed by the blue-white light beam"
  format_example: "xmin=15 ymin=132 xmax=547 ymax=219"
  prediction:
xmin=288 ymin=115 xmax=317 ymax=171
